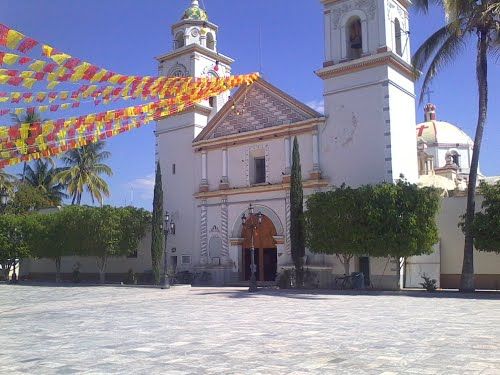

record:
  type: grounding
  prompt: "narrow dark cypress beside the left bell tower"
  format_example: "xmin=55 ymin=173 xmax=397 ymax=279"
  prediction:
xmin=151 ymin=162 xmax=165 ymax=285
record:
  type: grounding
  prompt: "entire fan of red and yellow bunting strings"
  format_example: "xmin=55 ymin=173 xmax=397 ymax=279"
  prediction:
xmin=0 ymin=24 xmax=259 ymax=168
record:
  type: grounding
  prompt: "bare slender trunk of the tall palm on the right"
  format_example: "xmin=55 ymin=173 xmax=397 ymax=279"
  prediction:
xmin=460 ymin=30 xmax=488 ymax=292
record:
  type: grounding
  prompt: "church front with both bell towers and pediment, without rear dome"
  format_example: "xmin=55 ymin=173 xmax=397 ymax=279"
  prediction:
xmin=156 ymin=0 xmax=418 ymax=288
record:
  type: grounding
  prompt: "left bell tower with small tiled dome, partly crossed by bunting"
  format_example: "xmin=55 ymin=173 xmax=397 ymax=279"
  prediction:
xmin=155 ymin=0 xmax=233 ymax=267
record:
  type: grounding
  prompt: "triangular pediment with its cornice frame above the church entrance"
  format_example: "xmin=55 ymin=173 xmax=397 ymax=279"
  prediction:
xmin=194 ymin=79 xmax=323 ymax=142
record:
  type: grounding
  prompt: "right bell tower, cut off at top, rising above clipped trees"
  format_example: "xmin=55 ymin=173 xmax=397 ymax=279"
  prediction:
xmin=316 ymin=0 xmax=418 ymax=186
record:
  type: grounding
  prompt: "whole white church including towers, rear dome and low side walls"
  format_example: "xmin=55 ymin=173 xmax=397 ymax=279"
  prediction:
xmin=21 ymin=0 xmax=500 ymax=289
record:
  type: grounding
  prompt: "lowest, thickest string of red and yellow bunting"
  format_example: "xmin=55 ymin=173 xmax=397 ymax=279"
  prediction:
xmin=0 ymin=73 xmax=259 ymax=168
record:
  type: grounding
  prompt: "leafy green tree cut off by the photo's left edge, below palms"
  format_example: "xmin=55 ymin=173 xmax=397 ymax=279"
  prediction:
xmin=0 ymin=214 xmax=30 ymax=280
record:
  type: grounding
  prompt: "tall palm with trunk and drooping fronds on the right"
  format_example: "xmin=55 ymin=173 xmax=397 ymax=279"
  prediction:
xmin=412 ymin=0 xmax=500 ymax=292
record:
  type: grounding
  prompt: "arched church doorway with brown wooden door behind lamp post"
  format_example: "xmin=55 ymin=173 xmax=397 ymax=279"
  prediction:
xmin=241 ymin=215 xmax=278 ymax=282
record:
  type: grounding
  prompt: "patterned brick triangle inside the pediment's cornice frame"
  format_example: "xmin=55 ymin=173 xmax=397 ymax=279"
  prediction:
xmin=208 ymin=85 xmax=312 ymax=139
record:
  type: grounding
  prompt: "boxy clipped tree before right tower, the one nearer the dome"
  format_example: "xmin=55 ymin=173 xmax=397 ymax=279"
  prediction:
xmin=366 ymin=180 xmax=440 ymax=272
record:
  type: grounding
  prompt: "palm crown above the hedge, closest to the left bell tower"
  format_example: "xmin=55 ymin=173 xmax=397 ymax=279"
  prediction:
xmin=56 ymin=142 xmax=113 ymax=205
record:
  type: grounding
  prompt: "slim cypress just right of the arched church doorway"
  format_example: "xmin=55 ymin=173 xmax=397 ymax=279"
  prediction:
xmin=290 ymin=137 xmax=306 ymax=288
